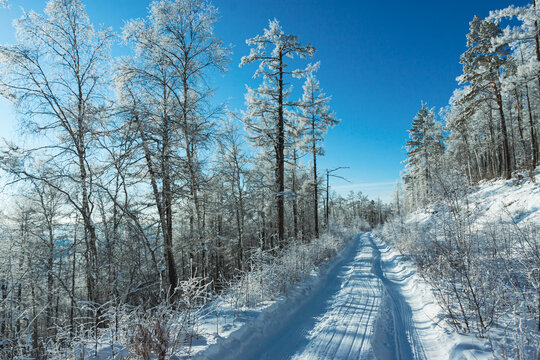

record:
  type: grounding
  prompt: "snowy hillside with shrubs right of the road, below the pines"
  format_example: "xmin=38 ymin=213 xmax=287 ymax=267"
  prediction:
xmin=380 ymin=170 xmax=540 ymax=359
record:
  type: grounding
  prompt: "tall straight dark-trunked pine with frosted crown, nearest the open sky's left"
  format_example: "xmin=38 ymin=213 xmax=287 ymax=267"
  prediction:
xmin=240 ymin=19 xmax=315 ymax=246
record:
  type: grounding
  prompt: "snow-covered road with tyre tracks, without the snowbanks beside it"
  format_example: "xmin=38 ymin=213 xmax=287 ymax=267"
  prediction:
xmin=207 ymin=233 xmax=426 ymax=360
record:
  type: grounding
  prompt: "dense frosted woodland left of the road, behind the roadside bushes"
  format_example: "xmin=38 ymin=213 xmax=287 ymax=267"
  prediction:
xmin=0 ymin=0 xmax=390 ymax=358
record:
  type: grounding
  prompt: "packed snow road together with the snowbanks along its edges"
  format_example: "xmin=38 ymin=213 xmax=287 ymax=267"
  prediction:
xmin=195 ymin=233 xmax=490 ymax=359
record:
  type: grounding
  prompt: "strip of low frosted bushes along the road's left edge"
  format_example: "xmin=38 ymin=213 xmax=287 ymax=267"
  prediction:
xmin=14 ymin=229 xmax=356 ymax=360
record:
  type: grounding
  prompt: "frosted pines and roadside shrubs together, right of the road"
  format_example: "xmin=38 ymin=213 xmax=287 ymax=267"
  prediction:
xmin=383 ymin=0 xmax=540 ymax=359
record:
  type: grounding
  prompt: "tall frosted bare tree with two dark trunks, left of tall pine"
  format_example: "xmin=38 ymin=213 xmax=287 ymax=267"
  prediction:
xmin=117 ymin=0 xmax=228 ymax=291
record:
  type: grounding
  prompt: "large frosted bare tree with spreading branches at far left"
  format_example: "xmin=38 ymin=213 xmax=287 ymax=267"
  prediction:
xmin=0 ymin=0 xmax=111 ymax=310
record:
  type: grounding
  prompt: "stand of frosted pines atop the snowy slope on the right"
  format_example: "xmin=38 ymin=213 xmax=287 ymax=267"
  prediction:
xmin=403 ymin=1 xmax=540 ymax=208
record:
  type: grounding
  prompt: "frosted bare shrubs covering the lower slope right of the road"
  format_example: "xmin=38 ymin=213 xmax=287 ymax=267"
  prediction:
xmin=379 ymin=201 xmax=540 ymax=359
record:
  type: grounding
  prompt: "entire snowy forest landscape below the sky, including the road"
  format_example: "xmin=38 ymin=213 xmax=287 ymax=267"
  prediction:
xmin=0 ymin=0 xmax=540 ymax=360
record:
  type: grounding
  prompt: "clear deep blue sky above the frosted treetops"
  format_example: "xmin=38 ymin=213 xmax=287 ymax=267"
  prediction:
xmin=0 ymin=0 xmax=529 ymax=201
